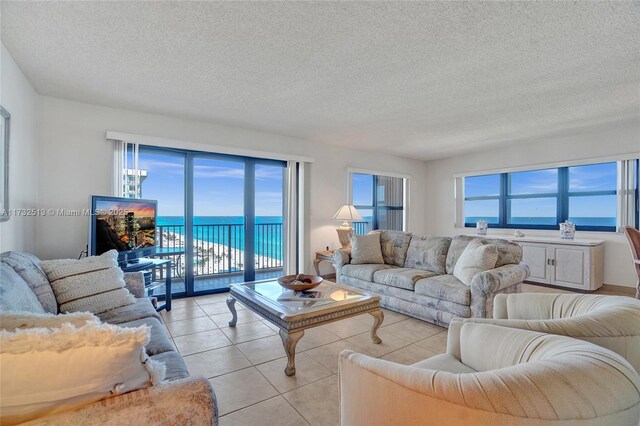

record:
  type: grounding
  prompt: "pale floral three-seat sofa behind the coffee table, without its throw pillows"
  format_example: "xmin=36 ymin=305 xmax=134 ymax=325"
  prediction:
xmin=334 ymin=231 xmax=529 ymax=327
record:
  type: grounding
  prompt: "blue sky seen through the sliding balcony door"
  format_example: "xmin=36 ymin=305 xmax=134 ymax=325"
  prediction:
xmin=139 ymin=151 xmax=283 ymax=216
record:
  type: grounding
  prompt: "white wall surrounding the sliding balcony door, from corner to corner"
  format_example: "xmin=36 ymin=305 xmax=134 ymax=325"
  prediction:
xmin=37 ymin=96 xmax=426 ymax=271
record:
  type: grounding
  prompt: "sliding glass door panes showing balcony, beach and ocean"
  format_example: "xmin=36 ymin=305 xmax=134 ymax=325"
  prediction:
xmin=139 ymin=147 xmax=285 ymax=295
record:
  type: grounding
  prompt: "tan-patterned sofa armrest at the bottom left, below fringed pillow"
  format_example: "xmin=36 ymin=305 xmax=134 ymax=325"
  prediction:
xmin=26 ymin=377 xmax=218 ymax=426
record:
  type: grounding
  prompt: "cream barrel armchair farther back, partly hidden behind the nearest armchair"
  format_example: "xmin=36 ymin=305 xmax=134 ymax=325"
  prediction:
xmin=447 ymin=293 xmax=640 ymax=372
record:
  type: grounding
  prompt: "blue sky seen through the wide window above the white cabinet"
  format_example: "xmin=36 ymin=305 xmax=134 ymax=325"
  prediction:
xmin=465 ymin=163 xmax=617 ymax=217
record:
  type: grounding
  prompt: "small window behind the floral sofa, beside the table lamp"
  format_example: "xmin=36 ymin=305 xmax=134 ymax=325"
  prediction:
xmin=351 ymin=173 xmax=404 ymax=234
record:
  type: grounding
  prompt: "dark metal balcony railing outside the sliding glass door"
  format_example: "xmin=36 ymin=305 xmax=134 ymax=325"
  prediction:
xmin=156 ymin=223 xmax=283 ymax=278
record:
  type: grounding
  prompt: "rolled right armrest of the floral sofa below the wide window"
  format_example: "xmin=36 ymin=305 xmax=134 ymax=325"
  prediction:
xmin=471 ymin=263 xmax=529 ymax=318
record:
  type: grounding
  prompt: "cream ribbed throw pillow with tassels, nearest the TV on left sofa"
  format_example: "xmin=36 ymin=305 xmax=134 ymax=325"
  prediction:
xmin=40 ymin=250 xmax=135 ymax=314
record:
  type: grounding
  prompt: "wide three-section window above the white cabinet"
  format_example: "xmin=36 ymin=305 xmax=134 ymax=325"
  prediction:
xmin=463 ymin=160 xmax=638 ymax=232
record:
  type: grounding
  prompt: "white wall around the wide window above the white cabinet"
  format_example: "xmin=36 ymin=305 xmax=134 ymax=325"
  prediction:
xmin=426 ymin=118 xmax=640 ymax=287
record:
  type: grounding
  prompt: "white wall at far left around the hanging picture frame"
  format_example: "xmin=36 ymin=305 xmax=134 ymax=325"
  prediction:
xmin=0 ymin=44 xmax=38 ymax=252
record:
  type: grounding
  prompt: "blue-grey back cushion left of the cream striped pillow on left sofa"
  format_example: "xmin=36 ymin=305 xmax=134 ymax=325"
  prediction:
xmin=0 ymin=251 xmax=58 ymax=314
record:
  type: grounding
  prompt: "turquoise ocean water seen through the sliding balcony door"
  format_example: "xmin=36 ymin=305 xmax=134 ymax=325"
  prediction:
xmin=156 ymin=216 xmax=283 ymax=260
